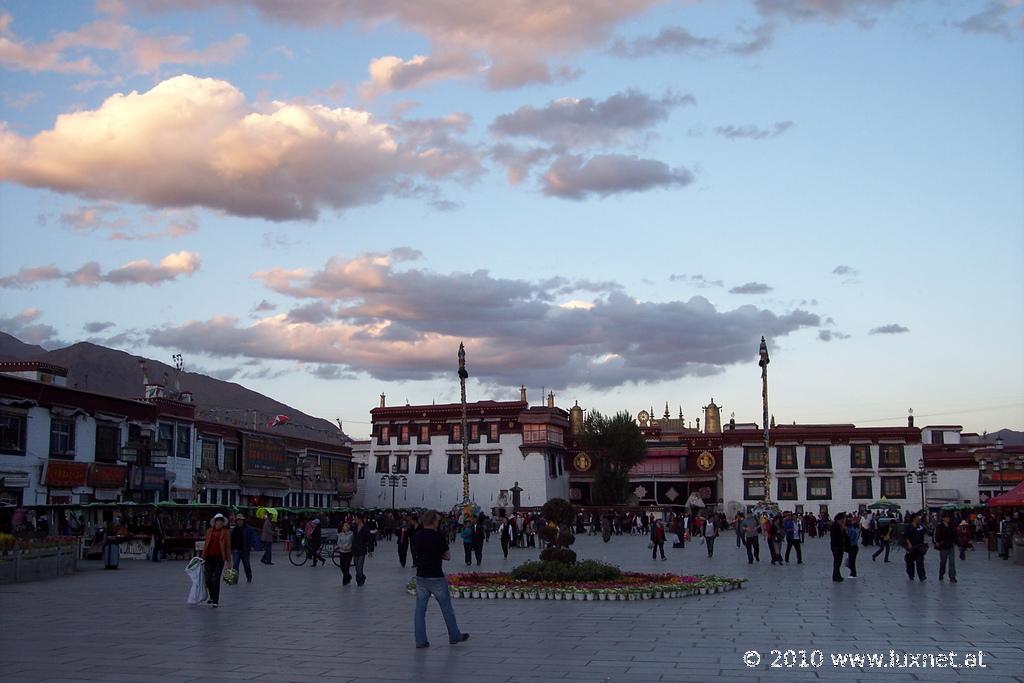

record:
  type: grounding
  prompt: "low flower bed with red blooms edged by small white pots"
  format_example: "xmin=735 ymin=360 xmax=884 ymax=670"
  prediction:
xmin=406 ymin=572 xmax=746 ymax=601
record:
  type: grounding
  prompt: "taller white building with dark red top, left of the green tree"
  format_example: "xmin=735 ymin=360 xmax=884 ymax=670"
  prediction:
xmin=360 ymin=390 xmax=568 ymax=511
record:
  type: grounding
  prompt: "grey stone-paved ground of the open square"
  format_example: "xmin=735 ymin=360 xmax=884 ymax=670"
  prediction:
xmin=0 ymin=537 xmax=1024 ymax=683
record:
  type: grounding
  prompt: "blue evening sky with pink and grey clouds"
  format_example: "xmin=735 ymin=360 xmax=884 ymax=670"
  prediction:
xmin=0 ymin=0 xmax=1024 ymax=438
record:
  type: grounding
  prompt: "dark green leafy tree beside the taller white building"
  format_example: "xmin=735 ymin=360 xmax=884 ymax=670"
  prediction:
xmin=580 ymin=411 xmax=647 ymax=505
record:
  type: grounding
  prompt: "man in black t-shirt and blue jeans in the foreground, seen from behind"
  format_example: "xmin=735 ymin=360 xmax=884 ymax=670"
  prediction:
xmin=413 ymin=510 xmax=469 ymax=648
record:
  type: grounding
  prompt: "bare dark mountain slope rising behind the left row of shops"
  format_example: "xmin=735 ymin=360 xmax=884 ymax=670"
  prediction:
xmin=0 ymin=333 xmax=350 ymax=443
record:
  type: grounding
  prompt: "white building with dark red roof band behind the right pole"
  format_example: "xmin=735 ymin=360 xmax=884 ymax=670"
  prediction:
xmin=722 ymin=425 xmax=923 ymax=515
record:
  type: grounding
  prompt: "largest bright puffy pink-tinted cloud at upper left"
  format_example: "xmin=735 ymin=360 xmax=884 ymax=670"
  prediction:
xmin=0 ymin=76 xmax=478 ymax=220
